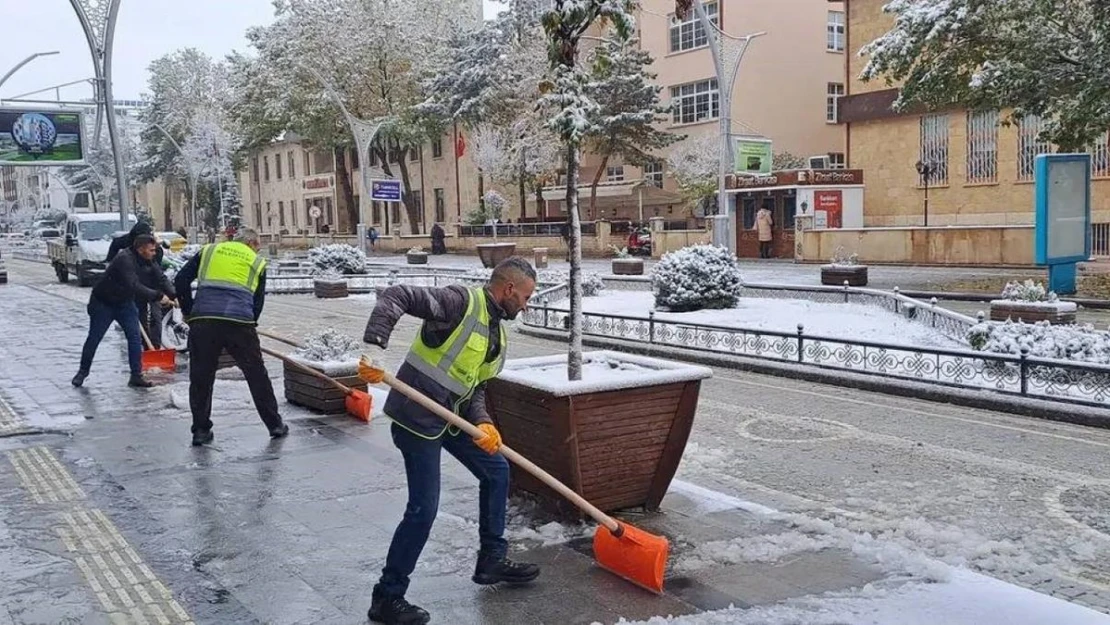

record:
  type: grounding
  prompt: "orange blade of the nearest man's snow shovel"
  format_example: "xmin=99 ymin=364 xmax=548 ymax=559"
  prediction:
xmin=594 ymin=523 xmax=670 ymax=595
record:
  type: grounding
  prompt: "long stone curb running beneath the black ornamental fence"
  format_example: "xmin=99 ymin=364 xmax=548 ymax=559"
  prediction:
xmin=517 ymin=325 xmax=1110 ymax=429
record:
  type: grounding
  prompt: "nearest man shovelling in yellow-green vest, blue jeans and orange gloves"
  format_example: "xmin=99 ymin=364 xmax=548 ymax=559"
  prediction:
xmin=360 ymin=256 xmax=539 ymax=625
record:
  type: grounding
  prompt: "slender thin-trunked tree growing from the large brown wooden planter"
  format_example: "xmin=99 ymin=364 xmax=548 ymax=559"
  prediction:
xmin=544 ymin=0 xmax=633 ymax=381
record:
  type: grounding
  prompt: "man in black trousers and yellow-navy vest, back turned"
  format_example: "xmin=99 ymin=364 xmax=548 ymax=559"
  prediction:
xmin=175 ymin=228 xmax=289 ymax=446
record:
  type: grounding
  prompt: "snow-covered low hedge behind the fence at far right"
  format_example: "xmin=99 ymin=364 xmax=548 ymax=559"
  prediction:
xmin=968 ymin=321 xmax=1110 ymax=364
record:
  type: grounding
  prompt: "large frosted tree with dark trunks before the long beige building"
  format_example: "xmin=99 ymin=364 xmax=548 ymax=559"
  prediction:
xmin=231 ymin=0 xmax=459 ymax=232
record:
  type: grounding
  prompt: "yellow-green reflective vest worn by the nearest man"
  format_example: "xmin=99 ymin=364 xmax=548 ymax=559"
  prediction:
xmin=405 ymin=288 xmax=506 ymax=399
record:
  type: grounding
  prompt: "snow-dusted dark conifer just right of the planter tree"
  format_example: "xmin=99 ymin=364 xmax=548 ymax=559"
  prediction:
xmin=587 ymin=37 xmax=682 ymax=215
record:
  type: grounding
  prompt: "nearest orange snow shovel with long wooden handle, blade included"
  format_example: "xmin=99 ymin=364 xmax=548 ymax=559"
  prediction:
xmin=362 ymin=355 xmax=670 ymax=594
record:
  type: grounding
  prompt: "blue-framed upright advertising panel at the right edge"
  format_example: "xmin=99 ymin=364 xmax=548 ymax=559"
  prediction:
xmin=1035 ymin=154 xmax=1091 ymax=294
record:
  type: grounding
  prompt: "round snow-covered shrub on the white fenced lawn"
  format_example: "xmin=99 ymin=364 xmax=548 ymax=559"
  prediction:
xmin=652 ymin=245 xmax=743 ymax=312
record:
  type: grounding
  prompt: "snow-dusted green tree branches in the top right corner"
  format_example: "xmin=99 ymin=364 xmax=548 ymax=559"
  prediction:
xmin=860 ymin=0 xmax=1110 ymax=151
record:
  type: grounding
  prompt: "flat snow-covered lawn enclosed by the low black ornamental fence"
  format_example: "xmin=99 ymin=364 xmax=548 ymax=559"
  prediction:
xmin=554 ymin=291 xmax=959 ymax=347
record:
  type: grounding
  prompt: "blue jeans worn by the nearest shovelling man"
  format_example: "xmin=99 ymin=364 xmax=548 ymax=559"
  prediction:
xmin=375 ymin=424 xmax=508 ymax=596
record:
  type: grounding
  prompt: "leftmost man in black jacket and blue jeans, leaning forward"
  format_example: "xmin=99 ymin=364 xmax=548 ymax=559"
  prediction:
xmin=72 ymin=234 xmax=171 ymax=389
